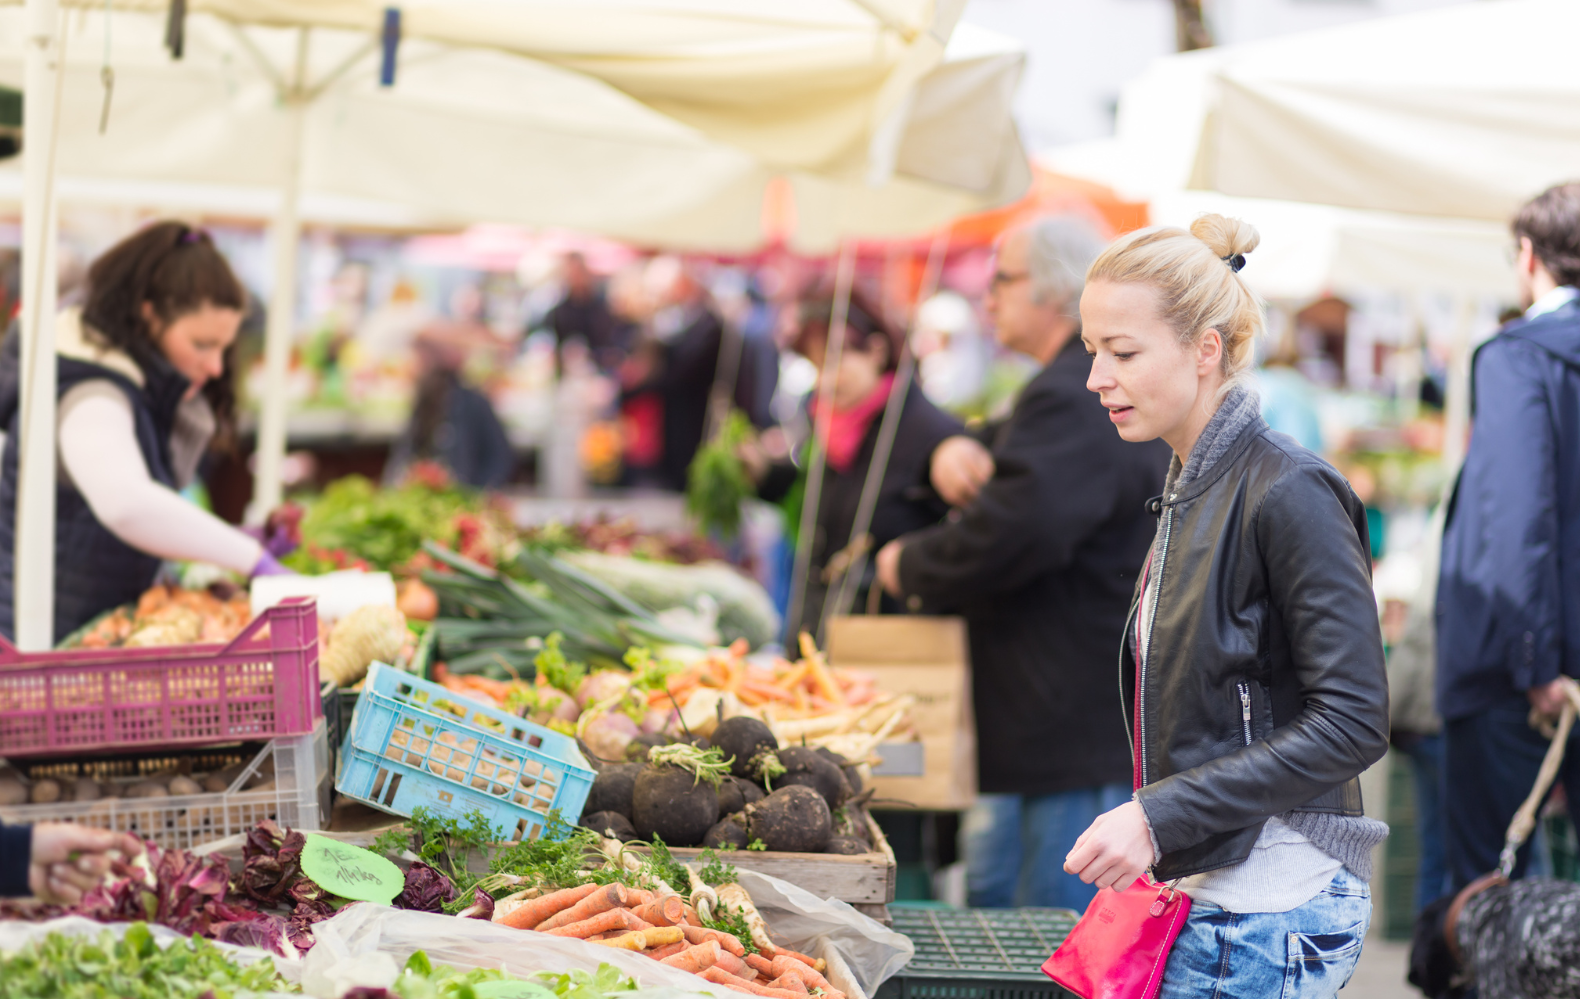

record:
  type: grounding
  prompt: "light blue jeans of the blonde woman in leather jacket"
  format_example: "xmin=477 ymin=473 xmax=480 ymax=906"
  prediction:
xmin=1158 ymin=868 xmax=1371 ymax=999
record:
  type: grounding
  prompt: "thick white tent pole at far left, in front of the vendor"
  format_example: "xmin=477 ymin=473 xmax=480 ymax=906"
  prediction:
xmin=13 ymin=0 xmax=63 ymax=651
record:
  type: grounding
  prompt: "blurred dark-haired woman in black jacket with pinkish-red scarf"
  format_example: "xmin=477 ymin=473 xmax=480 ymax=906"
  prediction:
xmin=743 ymin=291 xmax=964 ymax=635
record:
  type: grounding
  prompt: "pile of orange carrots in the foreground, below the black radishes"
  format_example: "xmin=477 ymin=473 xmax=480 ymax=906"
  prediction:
xmin=493 ymin=884 xmax=844 ymax=999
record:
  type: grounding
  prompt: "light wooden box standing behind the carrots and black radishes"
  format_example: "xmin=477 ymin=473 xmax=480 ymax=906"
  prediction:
xmin=828 ymin=615 xmax=976 ymax=811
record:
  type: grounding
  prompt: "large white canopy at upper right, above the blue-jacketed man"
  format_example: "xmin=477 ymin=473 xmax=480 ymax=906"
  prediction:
xmin=1119 ymin=0 xmax=1580 ymax=221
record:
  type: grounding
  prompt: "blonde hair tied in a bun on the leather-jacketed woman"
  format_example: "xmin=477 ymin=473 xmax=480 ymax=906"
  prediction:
xmin=1087 ymin=215 xmax=1266 ymax=383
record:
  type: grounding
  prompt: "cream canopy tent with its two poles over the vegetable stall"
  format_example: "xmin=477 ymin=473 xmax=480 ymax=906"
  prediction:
xmin=0 ymin=0 xmax=1029 ymax=647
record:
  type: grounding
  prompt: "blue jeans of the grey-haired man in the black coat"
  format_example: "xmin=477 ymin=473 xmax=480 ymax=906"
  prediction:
xmin=962 ymin=784 xmax=1130 ymax=912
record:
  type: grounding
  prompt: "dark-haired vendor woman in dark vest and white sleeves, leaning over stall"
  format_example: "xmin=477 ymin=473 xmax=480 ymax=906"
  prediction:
xmin=0 ymin=221 xmax=280 ymax=642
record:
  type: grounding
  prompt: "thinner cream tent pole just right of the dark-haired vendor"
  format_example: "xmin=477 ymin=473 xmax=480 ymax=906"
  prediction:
xmin=246 ymin=27 xmax=308 ymax=525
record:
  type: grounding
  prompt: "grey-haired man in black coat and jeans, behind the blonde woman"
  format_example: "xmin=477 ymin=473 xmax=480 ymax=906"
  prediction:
xmin=878 ymin=217 xmax=1169 ymax=912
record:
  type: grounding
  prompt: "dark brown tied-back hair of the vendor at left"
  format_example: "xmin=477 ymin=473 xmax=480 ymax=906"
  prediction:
xmin=82 ymin=221 xmax=246 ymax=449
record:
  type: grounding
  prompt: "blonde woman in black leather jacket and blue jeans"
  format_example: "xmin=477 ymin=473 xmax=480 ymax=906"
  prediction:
xmin=1065 ymin=215 xmax=1387 ymax=999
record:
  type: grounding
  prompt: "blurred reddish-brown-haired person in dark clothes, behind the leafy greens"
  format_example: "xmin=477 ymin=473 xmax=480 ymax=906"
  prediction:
xmin=384 ymin=322 xmax=515 ymax=488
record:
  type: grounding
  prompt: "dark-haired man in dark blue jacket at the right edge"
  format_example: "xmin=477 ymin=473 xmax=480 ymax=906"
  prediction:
xmin=1436 ymin=183 xmax=1580 ymax=887
